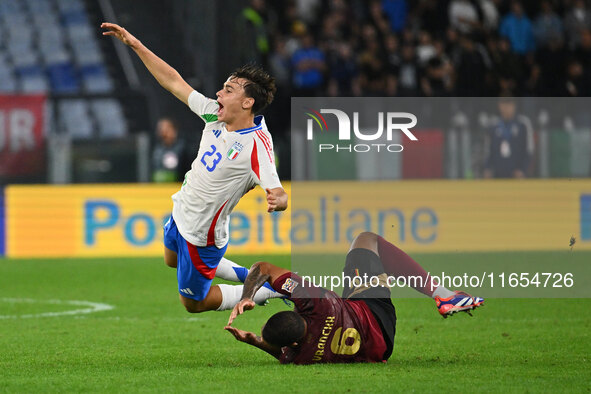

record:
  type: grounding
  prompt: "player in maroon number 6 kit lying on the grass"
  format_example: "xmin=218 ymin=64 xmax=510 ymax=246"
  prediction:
xmin=225 ymin=232 xmax=484 ymax=364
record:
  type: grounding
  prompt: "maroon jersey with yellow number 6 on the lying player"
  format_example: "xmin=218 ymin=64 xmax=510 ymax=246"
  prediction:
xmin=273 ymin=272 xmax=386 ymax=364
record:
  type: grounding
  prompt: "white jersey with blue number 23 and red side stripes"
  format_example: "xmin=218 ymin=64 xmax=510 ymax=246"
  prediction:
xmin=172 ymin=91 xmax=281 ymax=248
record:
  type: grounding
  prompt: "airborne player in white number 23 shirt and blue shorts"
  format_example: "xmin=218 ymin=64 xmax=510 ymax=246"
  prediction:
xmin=101 ymin=23 xmax=288 ymax=313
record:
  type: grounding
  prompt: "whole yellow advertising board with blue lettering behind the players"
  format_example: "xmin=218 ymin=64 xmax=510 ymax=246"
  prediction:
xmin=6 ymin=180 xmax=591 ymax=257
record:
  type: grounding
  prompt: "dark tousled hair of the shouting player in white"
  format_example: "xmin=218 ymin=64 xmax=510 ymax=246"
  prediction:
xmin=230 ymin=64 xmax=277 ymax=114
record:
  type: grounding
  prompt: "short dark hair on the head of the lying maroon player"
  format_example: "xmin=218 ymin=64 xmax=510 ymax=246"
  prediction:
xmin=261 ymin=311 xmax=306 ymax=347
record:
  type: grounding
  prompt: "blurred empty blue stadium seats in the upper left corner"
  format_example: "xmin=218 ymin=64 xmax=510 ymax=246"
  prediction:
xmin=0 ymin=0 xmax=128 ymax=138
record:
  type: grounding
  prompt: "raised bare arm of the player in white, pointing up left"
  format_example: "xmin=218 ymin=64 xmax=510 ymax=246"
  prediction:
xmin=101 ymin=22 xmax=193 ymax=104
